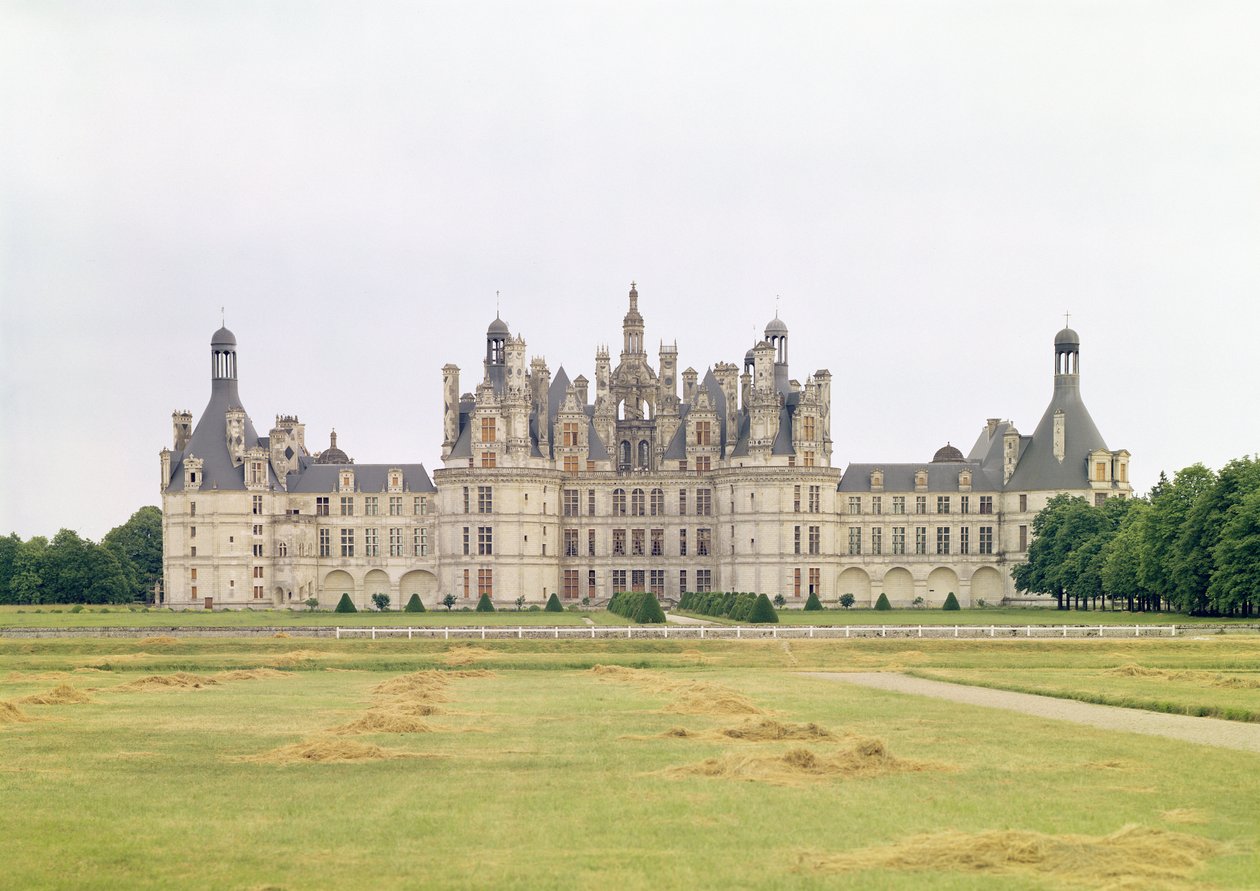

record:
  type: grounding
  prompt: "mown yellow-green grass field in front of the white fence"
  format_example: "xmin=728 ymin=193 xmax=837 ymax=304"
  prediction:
xmin=0 ymin=636 xmax=1260 ymax=888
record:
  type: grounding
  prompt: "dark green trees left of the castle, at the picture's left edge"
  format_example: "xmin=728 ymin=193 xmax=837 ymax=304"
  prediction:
xmin=0 ymin=507 xmax=161 ymax=604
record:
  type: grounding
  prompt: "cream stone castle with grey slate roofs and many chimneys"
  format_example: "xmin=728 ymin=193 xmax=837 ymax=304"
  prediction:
xmin=154 ymin=285 xmax=1133 ymax=609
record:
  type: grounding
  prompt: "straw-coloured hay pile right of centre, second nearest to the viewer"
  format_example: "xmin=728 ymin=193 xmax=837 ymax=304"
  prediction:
xmin=664 ymin=739 xmax=932 ymax=785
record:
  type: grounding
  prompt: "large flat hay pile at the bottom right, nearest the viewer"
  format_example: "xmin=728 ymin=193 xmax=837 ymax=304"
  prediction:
xmin=801 ymin=825 xmax=1220 ymax=887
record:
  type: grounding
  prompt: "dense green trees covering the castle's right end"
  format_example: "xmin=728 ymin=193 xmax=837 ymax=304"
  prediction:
xmin=1012 ymin=456 xmax=1260 ymax=616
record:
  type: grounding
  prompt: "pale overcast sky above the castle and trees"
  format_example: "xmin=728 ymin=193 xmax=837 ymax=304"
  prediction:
xmin=0 ymin=0 xmax=1260 ymax=538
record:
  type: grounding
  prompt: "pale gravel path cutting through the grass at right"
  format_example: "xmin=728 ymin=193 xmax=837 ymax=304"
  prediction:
xmin=808 ymin=672 xmax=1260 ymax=752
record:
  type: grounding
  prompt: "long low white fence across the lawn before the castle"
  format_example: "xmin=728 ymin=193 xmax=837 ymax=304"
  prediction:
xmin=335 ymin=625 xmax=1186 ymax=640
